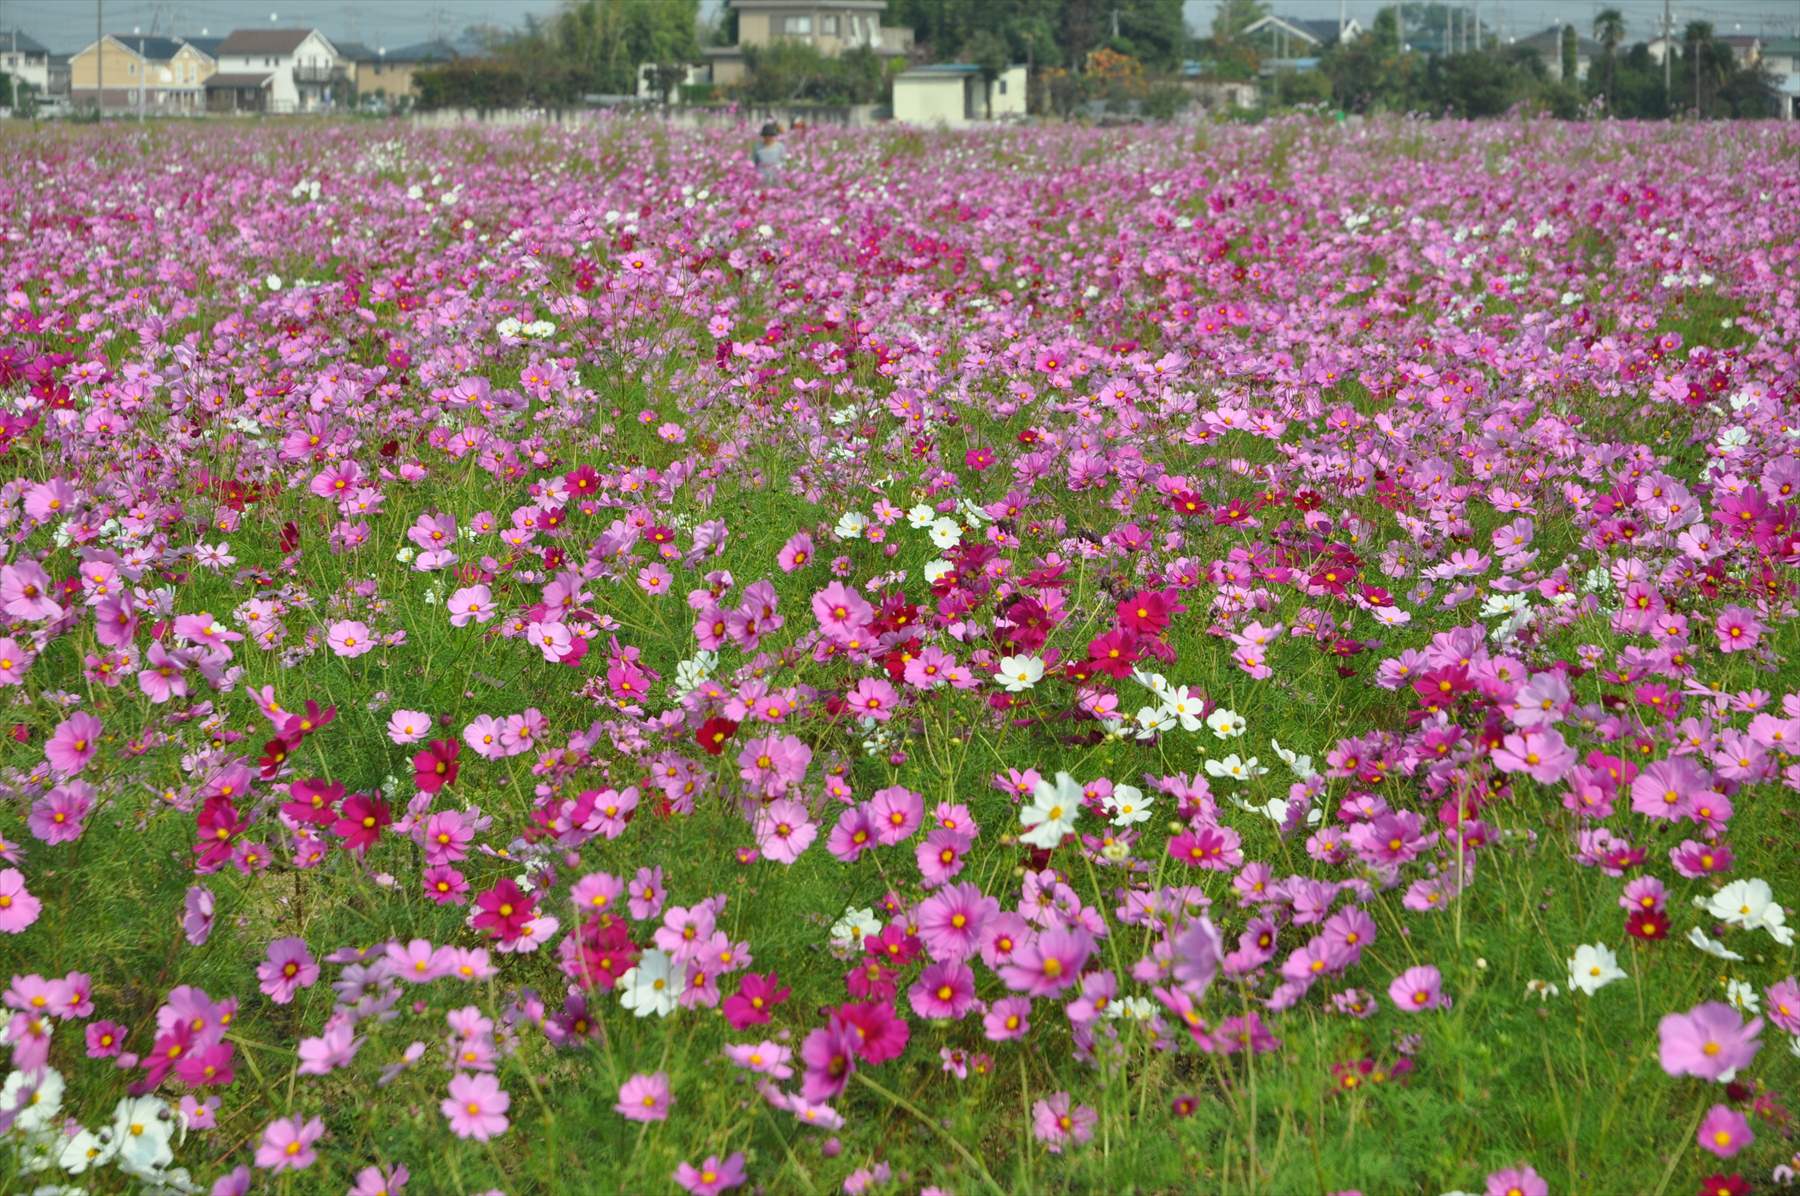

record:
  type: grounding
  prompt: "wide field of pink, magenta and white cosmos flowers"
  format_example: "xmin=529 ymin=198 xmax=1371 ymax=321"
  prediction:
xmin=0 ymin=121 xmax=1800 ymax=1196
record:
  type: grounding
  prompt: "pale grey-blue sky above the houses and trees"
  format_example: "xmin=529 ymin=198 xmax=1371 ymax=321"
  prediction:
xmin=0 ymin=0 xmax=1800 ymax=52
